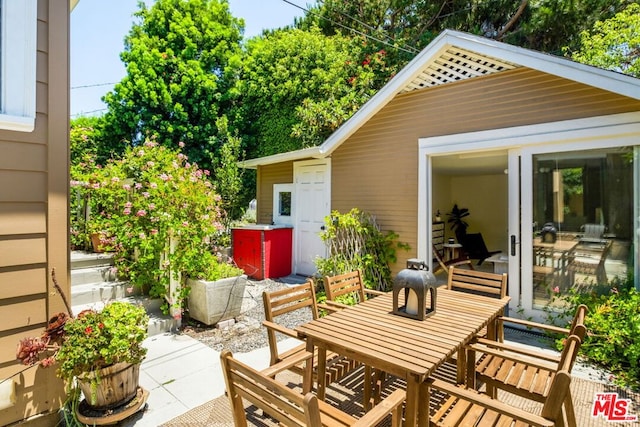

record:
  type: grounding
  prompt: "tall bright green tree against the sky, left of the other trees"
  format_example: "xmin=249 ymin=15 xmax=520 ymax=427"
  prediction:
xmin=104 ymin=0 xmax=244 ymax=171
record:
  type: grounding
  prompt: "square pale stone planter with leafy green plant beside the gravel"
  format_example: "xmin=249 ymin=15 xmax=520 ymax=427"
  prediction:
xmin=187 ymin=252 xmax=247 ymax=325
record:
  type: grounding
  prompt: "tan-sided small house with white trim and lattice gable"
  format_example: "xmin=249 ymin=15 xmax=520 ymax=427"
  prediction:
xmin=243 ymin=30 xmax=640 ymax=317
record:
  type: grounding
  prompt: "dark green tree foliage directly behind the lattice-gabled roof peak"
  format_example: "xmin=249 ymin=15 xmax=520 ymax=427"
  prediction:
xmin=299 ymin=0 xmax=635 ymax=62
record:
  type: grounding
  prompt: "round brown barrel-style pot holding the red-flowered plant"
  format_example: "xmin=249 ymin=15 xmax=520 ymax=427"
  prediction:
xmin=78 ymin=363 xmax=140 ymax=410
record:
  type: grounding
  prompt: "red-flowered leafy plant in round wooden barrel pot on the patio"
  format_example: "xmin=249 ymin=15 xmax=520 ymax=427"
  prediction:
xmin=55 ymin=301 xmax=149 ymax=409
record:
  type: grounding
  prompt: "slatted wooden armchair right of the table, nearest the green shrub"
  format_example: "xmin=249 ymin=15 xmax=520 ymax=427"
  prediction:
xmin=467 ymin=305 xmax=586 ymax=422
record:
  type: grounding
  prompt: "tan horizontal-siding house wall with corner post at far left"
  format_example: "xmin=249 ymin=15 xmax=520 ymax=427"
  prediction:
xmin=0 ymin=0 xmax=70 ymax=425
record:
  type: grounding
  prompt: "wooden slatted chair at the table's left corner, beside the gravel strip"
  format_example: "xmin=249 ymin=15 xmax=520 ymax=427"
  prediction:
xmin=262 ymin=280 xmax=360 ymax=392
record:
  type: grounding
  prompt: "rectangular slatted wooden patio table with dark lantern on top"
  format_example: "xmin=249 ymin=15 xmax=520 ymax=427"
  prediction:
xmin=295 ymin=288 xmax=510 ymax=426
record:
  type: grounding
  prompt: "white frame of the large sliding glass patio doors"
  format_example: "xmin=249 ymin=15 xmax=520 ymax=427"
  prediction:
xmin=418 ymin=112 xmax=640 ymax=319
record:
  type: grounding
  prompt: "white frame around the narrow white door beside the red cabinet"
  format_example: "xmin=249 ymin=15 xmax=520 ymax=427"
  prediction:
xmin=292 ymin=158 xmax=331 ymax=274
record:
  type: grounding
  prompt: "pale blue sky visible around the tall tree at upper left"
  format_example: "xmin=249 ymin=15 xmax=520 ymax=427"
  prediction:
xmin=70 ymin=0 xmax=314 ymax=119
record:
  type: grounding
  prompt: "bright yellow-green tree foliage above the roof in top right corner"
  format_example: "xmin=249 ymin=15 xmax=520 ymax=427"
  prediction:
xmin=572 ymin=4 xmax=640 ymax=77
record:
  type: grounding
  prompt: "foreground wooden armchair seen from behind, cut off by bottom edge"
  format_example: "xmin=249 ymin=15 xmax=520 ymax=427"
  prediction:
xmin=220 ymin=350 xmax=405 ymax=427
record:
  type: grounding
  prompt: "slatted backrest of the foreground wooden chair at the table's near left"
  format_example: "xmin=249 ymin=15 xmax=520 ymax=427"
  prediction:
xmin=220 ymin=350 xmax=321 ymax=427
